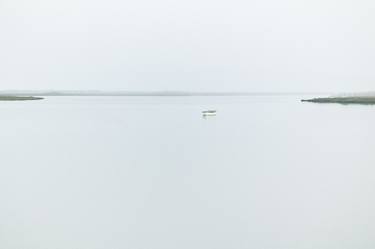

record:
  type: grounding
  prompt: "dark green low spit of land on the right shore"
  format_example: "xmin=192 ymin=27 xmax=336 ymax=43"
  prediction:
xmin=301 ymin=96 xmax=375 ymax=105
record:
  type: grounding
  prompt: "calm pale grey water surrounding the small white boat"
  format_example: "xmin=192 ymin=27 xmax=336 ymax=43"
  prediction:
xmin=0 ymin=96 xmax=375 ymax=249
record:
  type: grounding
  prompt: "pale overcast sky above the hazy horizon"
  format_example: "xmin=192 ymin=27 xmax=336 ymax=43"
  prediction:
xmin=0 ymin=0 xmax=375 ymax=91
